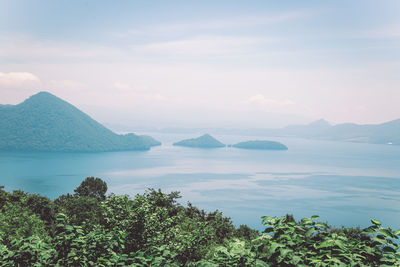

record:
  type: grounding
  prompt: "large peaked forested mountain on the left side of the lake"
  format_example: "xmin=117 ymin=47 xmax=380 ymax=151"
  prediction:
xmin=0 ymin=92 xmax=160 ymax=152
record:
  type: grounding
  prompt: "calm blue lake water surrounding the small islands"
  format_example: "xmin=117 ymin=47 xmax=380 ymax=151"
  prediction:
xmin=0 ymin=133 xmax=400 ymax=232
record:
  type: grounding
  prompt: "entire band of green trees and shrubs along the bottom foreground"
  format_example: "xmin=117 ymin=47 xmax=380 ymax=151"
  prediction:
xmin=0 ymin=177 xmax=400 ymax=266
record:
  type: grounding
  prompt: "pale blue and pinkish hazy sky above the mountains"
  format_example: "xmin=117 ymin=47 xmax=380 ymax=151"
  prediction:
xmin=0 ymin=0 xmax=400 ymax=128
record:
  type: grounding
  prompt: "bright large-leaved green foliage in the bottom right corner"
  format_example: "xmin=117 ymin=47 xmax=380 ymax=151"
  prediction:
xmin=247 ymin=215 xmax=400 ymax=266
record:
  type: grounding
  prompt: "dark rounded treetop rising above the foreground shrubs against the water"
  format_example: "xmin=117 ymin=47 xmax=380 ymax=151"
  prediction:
xmin=74 ymin=177 xmax=107 ymax=200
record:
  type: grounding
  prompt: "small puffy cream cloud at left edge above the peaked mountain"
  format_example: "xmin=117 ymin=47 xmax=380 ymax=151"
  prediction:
xmin=0 ymin=72 xmax=41 ymax=89
